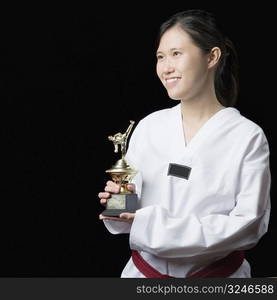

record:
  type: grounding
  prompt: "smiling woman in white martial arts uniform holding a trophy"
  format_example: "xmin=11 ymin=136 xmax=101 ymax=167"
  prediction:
xmin=99 ymin=10 xmax=270 ymax=278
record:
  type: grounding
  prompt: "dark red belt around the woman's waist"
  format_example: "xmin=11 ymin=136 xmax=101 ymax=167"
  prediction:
xmin=132 ymin=250 xmax=244 ymax=278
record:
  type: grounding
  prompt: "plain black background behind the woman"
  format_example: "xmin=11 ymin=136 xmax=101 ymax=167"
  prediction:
xmin=0 ymin=1 xmax=277 ymax=277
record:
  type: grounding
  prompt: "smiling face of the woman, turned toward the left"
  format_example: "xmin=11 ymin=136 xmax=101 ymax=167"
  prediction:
xmin=156 ymin=26 xmax=208 ymax=100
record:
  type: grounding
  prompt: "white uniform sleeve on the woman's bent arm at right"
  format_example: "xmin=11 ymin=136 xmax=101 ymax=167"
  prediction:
xmin=130 ymin=129 xmax=270 ymax=258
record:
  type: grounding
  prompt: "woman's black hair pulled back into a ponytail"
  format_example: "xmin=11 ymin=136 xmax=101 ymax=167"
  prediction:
xmin=157 ymin=9 xmax=239 ymax=107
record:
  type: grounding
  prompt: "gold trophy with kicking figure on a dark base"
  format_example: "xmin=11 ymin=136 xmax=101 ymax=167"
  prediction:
xmin=102 ymin=121 xmax=138 ymax=217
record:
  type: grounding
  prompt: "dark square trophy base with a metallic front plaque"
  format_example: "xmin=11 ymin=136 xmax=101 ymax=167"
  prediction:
xmin=102 ymin=194 xmax=138 ymax=217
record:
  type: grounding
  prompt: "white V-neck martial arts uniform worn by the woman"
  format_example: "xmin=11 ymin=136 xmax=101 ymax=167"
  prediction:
xmin=104 ymin=104 xmax=270 ymax=278
